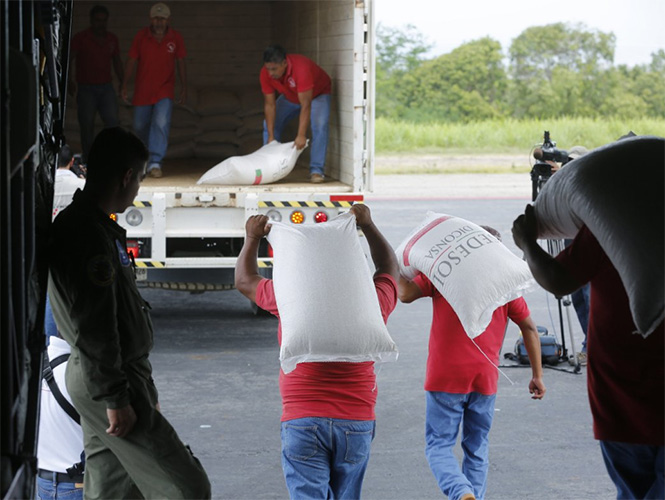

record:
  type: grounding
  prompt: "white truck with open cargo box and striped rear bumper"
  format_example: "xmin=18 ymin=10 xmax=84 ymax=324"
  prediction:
xmin=69 ymin=0 xmax=375 ymax=292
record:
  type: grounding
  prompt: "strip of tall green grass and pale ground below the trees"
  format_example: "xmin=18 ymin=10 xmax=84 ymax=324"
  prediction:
xmin=375 ymin=118 xmax=665 ymax=174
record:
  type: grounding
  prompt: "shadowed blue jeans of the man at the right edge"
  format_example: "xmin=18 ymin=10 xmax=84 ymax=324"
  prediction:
xmin=600 ymin=441 xmax=665 ymax=499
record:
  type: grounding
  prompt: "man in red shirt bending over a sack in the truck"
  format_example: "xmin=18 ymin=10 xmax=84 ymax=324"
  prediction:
xmin=259 ymin=44 xmax=330 ymax=183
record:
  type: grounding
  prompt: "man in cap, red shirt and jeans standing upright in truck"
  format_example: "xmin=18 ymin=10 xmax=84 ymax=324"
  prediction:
xmin=122 ymin=2 xmax=187 ymax=177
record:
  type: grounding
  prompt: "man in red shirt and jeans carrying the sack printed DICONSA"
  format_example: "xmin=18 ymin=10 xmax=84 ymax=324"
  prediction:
xmin=399 ymin=228 xmax=545 ymax=500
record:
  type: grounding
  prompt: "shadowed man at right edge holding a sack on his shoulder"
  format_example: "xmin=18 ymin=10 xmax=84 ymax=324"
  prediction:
xmin=513 ymin=205 xmax=665 ymax=498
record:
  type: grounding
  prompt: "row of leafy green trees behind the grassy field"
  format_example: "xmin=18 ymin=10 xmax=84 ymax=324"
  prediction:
xmin=376 ymin=23 xmax=665 ymax=122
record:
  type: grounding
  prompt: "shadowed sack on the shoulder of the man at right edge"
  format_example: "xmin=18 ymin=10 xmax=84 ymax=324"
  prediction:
xmin=534 ymin=136 xmax=665 ymax=336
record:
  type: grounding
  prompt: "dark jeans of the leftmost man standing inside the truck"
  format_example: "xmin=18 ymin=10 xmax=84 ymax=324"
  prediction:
xmin=76 ymin=83 xmax=118 ymax=163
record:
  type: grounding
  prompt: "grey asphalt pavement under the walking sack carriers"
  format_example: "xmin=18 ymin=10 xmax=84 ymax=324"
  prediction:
xmin=143 ymin=186 xmax=616 ymax=499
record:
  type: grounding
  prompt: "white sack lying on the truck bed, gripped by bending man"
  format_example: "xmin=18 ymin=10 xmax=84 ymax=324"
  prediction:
xmin=196 ymin=141 xmax=304 ymax=186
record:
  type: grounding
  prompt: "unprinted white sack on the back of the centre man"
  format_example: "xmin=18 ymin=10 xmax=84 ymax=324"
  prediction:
xmin=268 ymin=213 xmax=397 ymax=373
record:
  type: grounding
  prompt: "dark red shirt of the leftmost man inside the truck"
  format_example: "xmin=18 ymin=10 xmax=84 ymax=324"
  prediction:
xmin=70 ymin=28 xmax=120 ymax=85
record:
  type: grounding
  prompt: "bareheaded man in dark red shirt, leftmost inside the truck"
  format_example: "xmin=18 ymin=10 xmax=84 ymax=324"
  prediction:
xmin=68 ymin=5 xmax=123 ymax=164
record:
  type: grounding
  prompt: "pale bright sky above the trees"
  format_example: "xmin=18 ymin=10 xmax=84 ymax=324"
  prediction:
xmin=374 ymin=0 xmax=665 ymax=66
